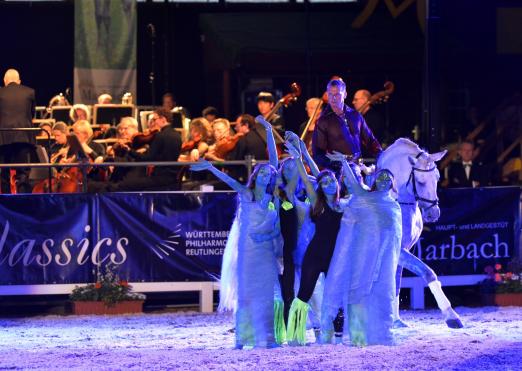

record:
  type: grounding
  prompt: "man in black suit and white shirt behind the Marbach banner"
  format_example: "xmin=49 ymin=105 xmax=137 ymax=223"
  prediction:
xmin=448 ymin=141 xmax=491 ymax=188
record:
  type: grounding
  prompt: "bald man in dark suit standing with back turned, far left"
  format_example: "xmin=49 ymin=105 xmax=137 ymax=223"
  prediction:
xmin=0 ymin=69 xmax=36 ymax=193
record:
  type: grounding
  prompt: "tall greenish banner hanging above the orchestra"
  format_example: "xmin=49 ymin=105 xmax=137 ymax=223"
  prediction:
xmin=74 ymin=0 xmax=137 ymax=104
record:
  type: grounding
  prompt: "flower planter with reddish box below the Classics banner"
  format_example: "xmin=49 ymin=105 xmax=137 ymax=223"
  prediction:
xmin=69 ymin=265 xmax=146 ymax=314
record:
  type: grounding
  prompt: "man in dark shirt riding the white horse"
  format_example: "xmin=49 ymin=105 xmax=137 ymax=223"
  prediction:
xmin=312 ymin=79 xmax=382 ymax=172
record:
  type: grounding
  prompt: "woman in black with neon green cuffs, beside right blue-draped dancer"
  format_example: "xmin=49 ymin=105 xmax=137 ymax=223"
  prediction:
xmin=280 ymin=143 xmax=342 ymax=345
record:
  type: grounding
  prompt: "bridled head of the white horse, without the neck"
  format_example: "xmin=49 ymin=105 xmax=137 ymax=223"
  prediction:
xmin=406 ymin=151 xmax=446 ymax=223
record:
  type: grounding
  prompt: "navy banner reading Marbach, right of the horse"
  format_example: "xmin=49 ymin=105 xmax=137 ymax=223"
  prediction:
xmin=411 ymin=187 xmax=522 ymax=275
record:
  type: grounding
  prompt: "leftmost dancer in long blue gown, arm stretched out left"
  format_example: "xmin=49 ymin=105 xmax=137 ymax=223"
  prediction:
xmin=191 ymin=161 xmax=282 ymax=349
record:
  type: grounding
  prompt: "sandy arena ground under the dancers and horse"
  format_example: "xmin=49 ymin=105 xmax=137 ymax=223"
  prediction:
xmin=0 ymin=307 xmax=522 ymax=371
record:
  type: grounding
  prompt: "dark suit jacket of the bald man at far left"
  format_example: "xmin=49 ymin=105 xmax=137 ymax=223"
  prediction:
xmin=0 ymin=83 xmax=36 ymax=145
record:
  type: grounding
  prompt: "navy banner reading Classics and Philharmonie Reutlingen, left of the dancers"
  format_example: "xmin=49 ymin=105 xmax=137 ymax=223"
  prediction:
xmin=0 ymin=193 xmax=236 ymax=285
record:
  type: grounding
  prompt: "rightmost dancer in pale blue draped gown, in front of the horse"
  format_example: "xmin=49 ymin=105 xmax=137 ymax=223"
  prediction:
xmin=322 ymin=154 xmax=402 ymax=346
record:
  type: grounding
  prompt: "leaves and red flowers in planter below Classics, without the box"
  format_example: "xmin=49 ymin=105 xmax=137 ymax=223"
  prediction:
xmin=69 ymin=265 xmax=146 ymax=306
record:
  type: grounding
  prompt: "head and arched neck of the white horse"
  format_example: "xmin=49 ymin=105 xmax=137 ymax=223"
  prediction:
xmin=377 ymin=138 xmax=446 ymax=223
